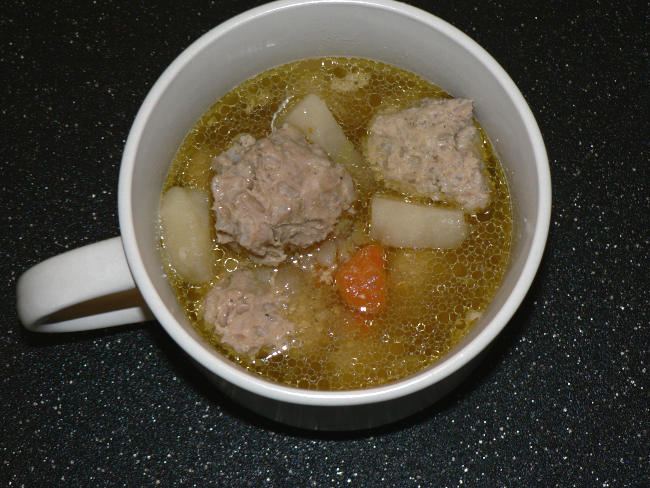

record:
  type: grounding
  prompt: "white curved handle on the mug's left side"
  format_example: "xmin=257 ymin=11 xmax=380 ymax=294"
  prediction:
xmin=16 ymin=237 xmax=153 ymax=332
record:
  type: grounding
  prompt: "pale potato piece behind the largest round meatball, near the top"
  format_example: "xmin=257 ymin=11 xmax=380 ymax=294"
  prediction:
xmin=284 ymin=93 xmax=354 ymax=160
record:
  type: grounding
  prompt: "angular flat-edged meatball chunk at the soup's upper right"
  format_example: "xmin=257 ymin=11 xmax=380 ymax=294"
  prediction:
xmin=366 ymin=98 xmax=490 ymax=212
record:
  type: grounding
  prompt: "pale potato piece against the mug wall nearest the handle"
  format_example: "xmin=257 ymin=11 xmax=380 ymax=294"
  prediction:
xmin=160 ymin=186 xmax=215 ymax=283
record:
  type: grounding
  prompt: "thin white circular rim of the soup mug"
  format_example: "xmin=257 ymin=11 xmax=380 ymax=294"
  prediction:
xmin=118 ymin=0 xmax=551 ymax=406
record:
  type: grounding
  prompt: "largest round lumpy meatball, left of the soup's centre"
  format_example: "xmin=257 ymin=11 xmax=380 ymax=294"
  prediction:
xmin=212 ymin=125 xmax=355 ymax=265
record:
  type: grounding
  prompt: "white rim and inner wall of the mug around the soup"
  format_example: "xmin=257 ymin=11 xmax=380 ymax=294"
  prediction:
xmin=119 ymin=1 xmax=550 ymax=405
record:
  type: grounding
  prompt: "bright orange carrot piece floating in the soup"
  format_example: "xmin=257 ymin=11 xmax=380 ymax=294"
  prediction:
xmin=336 ymin=244 xmax=386 ymax=314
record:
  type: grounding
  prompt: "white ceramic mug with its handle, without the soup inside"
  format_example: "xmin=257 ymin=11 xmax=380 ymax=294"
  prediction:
xmin=17 ymin=0 xmax=551 ymax=430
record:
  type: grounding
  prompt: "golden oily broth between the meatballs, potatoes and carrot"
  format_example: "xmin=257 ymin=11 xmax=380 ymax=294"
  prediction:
xmin=162 ymin=57 xmax=512 ymax=390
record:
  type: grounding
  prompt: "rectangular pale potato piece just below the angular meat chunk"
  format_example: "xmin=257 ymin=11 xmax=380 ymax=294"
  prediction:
xmin=370 ymin=196 xmax=468 ymax=249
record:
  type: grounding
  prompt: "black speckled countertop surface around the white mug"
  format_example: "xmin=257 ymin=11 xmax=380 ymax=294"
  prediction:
xmin=0 ymin=0 xmax=650 ymax=487
